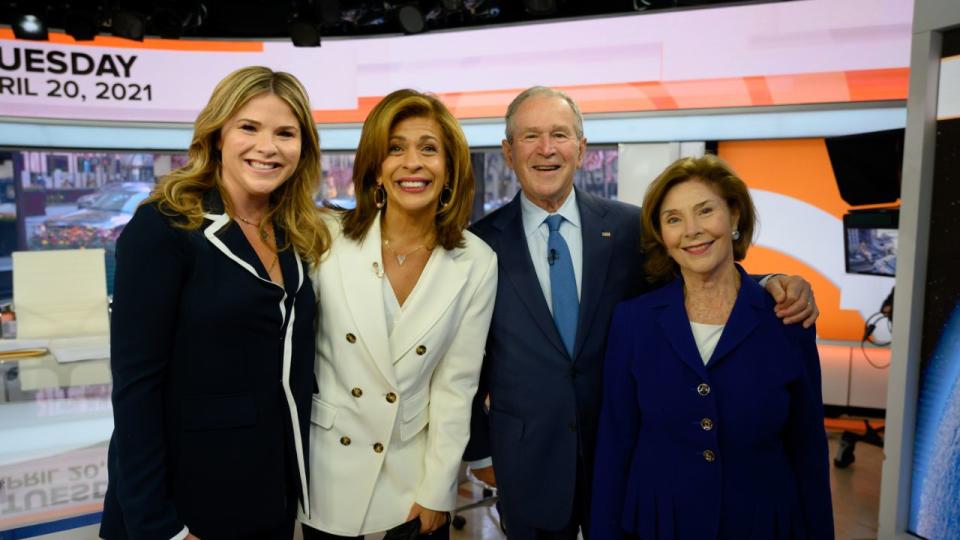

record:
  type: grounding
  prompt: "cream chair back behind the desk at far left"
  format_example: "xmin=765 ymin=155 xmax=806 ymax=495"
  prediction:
xmin=13 ymin=249 xmax=110 ymax=339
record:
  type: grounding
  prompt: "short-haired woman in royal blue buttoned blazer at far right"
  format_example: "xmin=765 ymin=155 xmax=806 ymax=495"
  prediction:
xmin=591 ymin=155 xmax=833 ymax=540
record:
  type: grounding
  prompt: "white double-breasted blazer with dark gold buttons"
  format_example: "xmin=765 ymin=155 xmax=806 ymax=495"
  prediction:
xmin=300 ymin=212 xmax=497 ymax=536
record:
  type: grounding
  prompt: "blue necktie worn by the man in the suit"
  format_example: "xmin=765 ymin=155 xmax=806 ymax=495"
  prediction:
xmin=544 ymin=214 xmax=580 ymax=358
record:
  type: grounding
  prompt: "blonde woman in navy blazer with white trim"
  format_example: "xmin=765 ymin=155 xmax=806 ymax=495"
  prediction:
xmin=100 ymin=67 xmax=330 ymax=540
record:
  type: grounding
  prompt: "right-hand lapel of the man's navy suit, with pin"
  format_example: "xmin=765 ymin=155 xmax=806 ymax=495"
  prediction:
xmin=573 ymin=190 xmax=616 ymax=358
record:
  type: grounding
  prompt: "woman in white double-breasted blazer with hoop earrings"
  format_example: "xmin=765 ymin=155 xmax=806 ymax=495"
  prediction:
xmin=301 ymin=90 xmax=497 ymax=540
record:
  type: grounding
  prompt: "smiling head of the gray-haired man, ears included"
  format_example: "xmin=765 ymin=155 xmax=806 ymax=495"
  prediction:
xmin=503 ymin=95 xmax=587 ymax=212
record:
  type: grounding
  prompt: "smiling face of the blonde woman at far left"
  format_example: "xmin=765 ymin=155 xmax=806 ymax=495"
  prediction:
xmin=218 ymin=94 xmax=301 ymax=205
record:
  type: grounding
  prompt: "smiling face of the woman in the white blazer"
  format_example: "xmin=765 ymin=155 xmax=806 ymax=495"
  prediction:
xmin=377 ymin=116 xmax=447 ymax=216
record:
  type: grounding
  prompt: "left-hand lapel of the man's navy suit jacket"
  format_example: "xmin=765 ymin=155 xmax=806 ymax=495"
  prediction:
xmin=494 ymin=193 xmax=567 ymax=356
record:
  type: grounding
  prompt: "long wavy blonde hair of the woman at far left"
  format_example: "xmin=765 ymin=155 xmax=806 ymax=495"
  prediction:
xmin=145 ymin=66 xmax=330 ymax=264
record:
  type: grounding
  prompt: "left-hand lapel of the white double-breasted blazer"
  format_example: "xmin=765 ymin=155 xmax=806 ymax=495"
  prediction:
xmin=340 ymin=216 xmax=397 ymax=386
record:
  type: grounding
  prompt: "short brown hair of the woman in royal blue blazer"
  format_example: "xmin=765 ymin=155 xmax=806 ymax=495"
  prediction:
xmin=640 ymin=154 xmax=757 ymax=283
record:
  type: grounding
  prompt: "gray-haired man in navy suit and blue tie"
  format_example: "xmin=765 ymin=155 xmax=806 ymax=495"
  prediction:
xmin=464 ymin=87 xmax=818 ymax=540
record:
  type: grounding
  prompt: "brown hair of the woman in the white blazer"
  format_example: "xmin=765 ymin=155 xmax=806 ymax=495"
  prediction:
xmin=343 ymin=89 xmax=475 ymax=249
